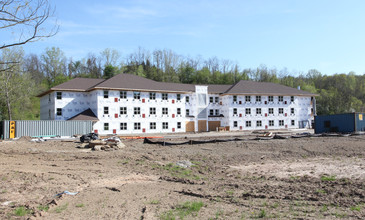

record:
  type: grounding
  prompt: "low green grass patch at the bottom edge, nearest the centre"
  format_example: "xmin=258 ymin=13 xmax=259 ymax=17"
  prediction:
xmin=160 ymin=202 xmax=204 ymax=220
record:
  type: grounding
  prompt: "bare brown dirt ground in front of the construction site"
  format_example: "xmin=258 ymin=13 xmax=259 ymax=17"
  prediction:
xmin=0 ymin=133 xmax=365 ymax=219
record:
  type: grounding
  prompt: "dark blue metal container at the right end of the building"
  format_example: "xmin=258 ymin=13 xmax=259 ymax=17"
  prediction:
xmin=314 ymin=112 xmax=365 ymax=134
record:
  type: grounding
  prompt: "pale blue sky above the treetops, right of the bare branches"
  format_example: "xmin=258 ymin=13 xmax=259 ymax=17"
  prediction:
xmin=4 ymin=0 xmax=365 ymax=75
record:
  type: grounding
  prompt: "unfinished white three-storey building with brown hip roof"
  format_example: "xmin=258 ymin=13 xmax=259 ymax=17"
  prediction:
xmin=38 ymin=74 xmax=317 ymax=135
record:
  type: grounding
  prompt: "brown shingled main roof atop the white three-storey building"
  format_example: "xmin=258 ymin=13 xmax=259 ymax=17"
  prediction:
xmin=38 ymin=74 xmax=316 ymax=97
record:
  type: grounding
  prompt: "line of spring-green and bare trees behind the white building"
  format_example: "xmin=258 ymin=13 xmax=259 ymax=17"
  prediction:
xmin=0 ymin=47 xmax=365 ymax=120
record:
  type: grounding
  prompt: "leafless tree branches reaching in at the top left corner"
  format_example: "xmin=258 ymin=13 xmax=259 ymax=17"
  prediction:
xmin=0 ymin=0 xmax=59 ymax=50
